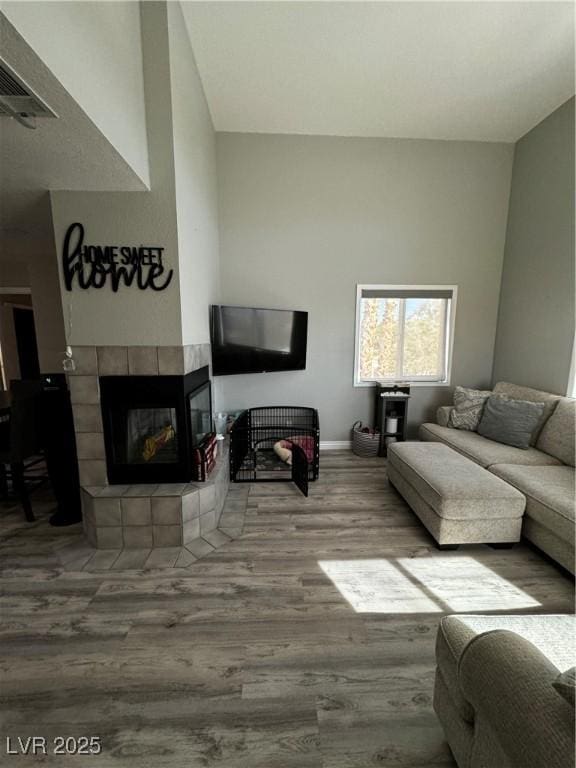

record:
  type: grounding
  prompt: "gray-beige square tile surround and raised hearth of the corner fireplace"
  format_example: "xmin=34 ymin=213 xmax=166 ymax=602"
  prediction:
xmin=68 ymin=344 xmax=229 ymax=551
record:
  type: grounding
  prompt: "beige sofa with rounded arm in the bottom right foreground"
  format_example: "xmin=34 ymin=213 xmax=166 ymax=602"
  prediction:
xmin=434 ymin=615 xmax=576 ymax=768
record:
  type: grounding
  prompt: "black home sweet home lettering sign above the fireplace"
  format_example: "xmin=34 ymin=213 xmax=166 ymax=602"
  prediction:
xmin=62 ymin=222 xmax=174 ymax=293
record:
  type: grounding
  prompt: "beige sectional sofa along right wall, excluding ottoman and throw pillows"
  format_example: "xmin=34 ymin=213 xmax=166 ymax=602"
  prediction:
xmin=419 ymin=382 xmax=576 ymax=573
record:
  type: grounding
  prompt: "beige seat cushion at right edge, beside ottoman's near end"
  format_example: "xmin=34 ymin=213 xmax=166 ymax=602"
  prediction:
xmin=490 ymin=464 xmax=576 ymax=542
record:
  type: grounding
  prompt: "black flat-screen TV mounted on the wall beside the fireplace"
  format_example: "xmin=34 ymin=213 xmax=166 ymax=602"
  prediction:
xmin=210 ymin=306 xmax=308 ymax=376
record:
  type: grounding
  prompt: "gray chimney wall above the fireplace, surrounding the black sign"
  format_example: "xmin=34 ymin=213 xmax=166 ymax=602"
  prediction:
xmin=51 ymin=3 xmax=218 ymax=346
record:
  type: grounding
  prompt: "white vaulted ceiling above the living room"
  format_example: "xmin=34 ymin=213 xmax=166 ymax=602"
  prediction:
xmin=182 ymin=1 xmax=574 ymax=141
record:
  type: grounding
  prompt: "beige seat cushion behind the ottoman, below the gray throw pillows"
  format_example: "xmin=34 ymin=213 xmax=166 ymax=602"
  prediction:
xmin=419 ymin=424 xmax=561 ymax=467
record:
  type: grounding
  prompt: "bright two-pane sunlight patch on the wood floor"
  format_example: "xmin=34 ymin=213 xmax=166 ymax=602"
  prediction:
xmin=318 ymin=556 xmax=540 ymax=614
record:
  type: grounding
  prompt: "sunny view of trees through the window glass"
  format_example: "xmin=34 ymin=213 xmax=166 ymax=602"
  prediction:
xmin=359 ymin=298 xmax=448 ymax=380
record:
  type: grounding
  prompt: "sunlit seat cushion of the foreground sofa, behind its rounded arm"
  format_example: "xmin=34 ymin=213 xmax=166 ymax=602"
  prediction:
xmin=436 ymin=614 xmax=576 ymax=723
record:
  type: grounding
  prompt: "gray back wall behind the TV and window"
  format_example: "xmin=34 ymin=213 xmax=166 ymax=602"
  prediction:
xmin=217 ymin=134 xmax=513 ymax=441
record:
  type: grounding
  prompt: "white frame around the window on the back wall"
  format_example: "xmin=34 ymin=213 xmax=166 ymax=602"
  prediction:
xmin=353 ymin=283 xmax=458 ymax=387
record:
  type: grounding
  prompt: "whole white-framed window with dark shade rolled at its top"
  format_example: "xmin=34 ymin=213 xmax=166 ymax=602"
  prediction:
xmin=354 ymin=285 xmax=457 ymax=386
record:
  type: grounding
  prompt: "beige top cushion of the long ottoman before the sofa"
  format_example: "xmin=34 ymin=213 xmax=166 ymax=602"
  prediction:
xmin=388 ymin=443 xmax=526 ymax=520
